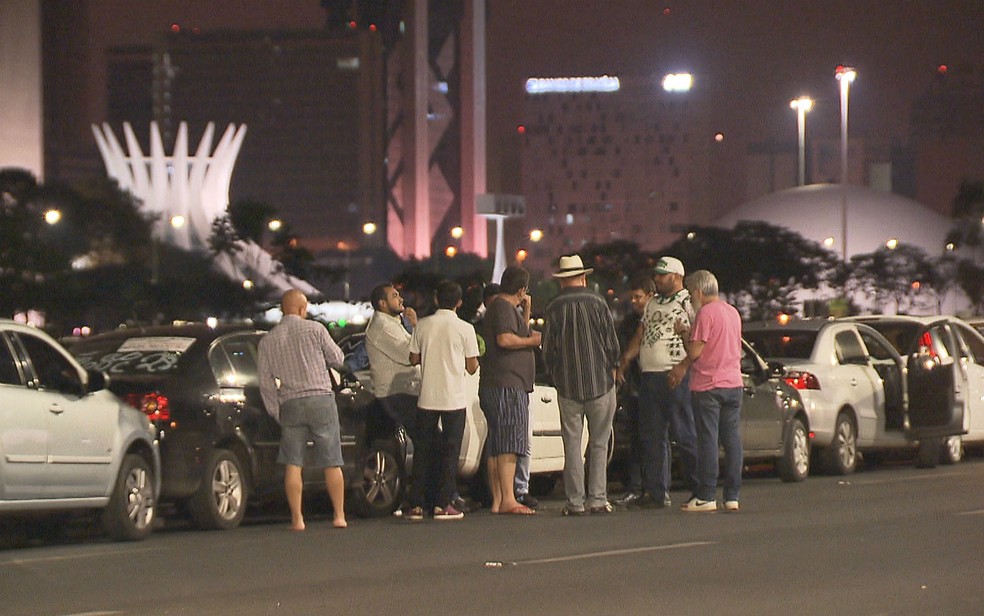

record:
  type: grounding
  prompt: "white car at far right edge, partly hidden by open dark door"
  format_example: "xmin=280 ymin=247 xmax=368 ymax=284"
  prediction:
xmin=852 ymin=315 xmax=984 ymax=464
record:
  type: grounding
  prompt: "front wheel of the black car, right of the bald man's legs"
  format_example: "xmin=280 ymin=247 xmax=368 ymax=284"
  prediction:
xmin=352 ymin=440 xmax=406 ymax=517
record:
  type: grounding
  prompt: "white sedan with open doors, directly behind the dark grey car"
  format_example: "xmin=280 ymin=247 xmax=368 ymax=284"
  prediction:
xmin=742 ymin=320 xmax=964 ymax=474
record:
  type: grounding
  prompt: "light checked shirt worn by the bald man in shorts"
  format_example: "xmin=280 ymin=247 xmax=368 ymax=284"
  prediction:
xmin=256 ymin=314 xmax=345 ymax=419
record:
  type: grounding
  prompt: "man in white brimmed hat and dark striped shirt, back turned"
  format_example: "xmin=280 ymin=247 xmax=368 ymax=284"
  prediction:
xmin=543 ymin=255 xmax=619 ymax=515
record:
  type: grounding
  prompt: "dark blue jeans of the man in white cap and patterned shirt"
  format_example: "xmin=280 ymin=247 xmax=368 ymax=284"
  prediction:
xmin=639 ymin=372 xmax=697 ymax=499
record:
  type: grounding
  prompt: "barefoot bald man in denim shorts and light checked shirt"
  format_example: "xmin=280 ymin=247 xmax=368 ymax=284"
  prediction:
xmin=257 ymin=289 xmax=348 ymax=531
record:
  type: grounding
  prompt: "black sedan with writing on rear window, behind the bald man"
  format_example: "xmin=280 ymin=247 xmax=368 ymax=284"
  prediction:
xmin=70 ymin=324 xmax=406 ymax=529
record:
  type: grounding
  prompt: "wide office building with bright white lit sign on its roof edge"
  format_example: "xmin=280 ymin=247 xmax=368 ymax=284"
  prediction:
xmin=520 ymin=77 xmax=717 ymax=272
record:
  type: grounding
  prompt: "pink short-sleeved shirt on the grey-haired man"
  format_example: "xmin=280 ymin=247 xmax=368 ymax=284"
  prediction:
xmin=690 ymin=300 xmax=743 ymax=391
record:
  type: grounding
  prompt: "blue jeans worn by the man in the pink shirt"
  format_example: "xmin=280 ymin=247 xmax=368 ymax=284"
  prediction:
xmin=692 ymin=387 xmax=744 ymax=501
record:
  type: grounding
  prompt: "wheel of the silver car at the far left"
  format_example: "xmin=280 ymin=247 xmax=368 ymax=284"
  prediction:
xmin=102 ymin=453 xmax=157 ymax=541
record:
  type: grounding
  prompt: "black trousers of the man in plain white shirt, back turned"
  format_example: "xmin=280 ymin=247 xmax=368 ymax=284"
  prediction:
xmin=410 ymin=407 xmax=465 ymax=509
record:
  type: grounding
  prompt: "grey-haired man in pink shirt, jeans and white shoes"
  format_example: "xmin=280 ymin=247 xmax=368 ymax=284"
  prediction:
xmin=669 ymin=270 xmax=744 ymax=512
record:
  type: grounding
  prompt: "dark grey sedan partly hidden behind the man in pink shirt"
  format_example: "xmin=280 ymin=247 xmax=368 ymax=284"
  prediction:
xmin=609 ymin=340 xmax=811 ymax=482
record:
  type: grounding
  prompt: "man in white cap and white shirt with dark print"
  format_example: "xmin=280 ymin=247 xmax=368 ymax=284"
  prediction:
xmin=619 ymin=257 xmax=697 ymax=507
